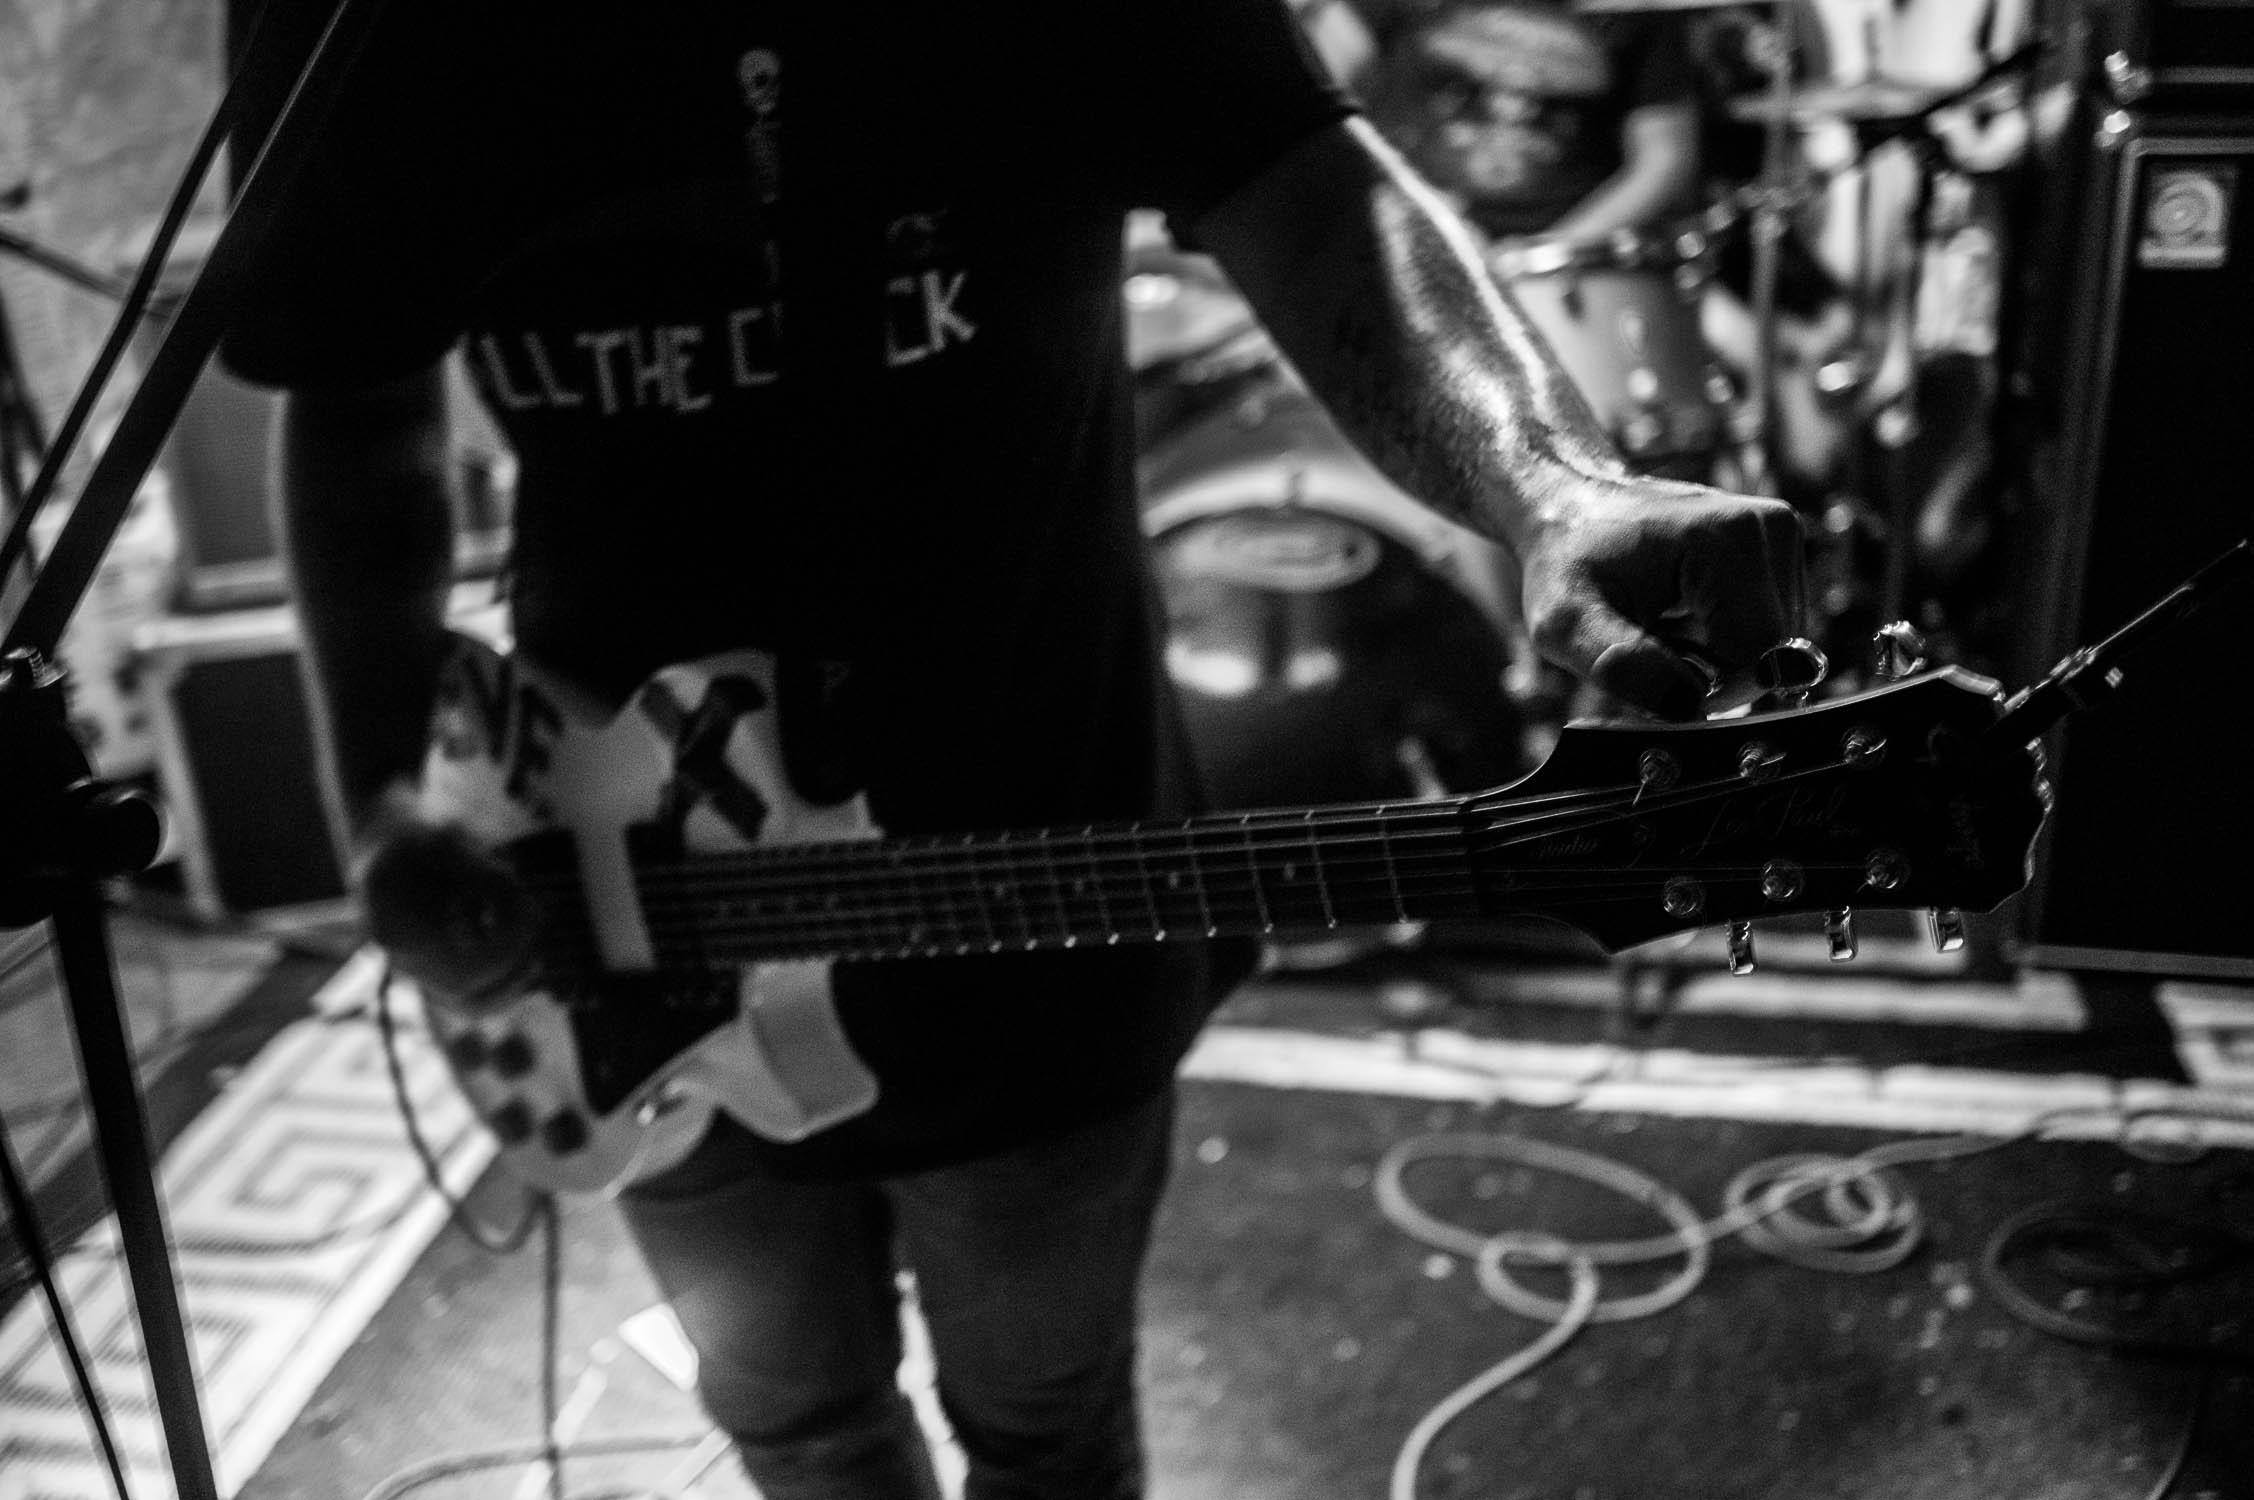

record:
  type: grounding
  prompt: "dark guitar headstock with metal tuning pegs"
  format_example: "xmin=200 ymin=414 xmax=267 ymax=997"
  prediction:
xmin=1467 ymin=668 xmax=2049 ymax=952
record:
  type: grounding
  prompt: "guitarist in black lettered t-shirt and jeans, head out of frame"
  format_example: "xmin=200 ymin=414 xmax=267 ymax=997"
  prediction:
xmin=225 ymin=0 xmax=1801 ymax=1500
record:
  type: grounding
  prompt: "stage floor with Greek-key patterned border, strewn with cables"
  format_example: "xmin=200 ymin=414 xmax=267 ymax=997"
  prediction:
xmin=0 ymin=911 xmax=2254 ymax=1500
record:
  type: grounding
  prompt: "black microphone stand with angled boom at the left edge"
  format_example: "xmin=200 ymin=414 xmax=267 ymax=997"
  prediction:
xmin=0 ymin=0 xmax=381 ymax=1500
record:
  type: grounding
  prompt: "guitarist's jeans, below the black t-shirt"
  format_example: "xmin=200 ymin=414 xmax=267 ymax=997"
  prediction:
xmin=622 ymin=1094 xmax=1174 ymax=1500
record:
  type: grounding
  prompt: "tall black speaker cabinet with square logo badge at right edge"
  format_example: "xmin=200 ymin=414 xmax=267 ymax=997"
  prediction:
xmin=2020 ymin=115 xmax=2254 ymax=979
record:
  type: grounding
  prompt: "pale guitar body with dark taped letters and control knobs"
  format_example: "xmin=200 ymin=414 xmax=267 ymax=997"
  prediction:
xmin=421 ymin=638 xmax=879 ymax=1193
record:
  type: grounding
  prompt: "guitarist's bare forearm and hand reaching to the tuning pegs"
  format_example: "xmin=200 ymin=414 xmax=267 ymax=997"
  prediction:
xmin=1195 ymin=120 xmax=1801 ymax=713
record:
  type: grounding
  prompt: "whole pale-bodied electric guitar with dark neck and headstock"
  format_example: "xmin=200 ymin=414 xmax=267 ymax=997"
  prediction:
xmin=421 ymin=638 xmax=2049 ymax=1193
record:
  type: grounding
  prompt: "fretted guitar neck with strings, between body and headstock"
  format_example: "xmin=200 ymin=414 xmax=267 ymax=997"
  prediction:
xmin=617 ymin=801 xmax=1479 ymax=963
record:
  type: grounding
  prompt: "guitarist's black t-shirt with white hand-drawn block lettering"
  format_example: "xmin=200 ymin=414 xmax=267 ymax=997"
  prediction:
xmin=225 ymin=0 xmax=1350 ymax=1171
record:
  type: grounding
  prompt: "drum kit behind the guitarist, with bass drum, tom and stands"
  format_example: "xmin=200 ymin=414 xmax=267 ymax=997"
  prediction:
xmin=1125 ymin=0 xmax=2026 ymax=821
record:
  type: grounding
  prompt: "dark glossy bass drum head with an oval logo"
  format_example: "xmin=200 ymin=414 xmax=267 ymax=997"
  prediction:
xmin=1152 ymin=505 xmax=1526 ymax=808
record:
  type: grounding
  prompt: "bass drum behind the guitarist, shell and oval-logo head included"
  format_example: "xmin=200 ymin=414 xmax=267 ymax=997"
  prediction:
xmin=1143 ymin=381 xmax=1528 ymax=808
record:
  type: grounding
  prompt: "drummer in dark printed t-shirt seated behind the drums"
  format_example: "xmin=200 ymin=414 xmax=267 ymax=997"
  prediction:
xmin=1366 ymin=0 xmax=1700 ymax=241
